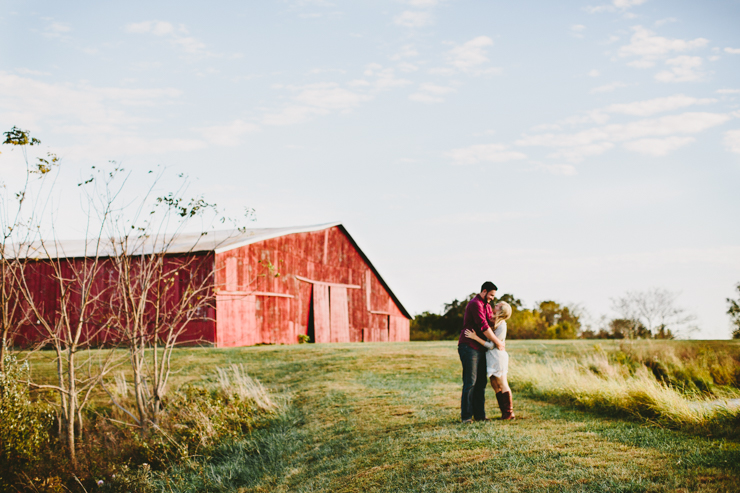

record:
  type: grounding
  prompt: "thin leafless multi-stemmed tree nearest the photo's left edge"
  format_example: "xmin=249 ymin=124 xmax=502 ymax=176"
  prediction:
xmin=3 ymin=137 xmax=124 ymax=467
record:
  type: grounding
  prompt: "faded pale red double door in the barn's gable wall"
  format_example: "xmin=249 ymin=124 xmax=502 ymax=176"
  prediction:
xmin=313 ymin=283 xmax=349 ymax=343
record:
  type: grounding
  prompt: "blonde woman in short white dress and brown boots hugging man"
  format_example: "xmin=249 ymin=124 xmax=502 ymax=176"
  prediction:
xmin=465 ymin=301 xmax=515 ymax=419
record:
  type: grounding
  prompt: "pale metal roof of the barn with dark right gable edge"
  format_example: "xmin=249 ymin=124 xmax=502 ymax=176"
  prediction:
xmin=6 ymin=222 xmax=413 ymax=318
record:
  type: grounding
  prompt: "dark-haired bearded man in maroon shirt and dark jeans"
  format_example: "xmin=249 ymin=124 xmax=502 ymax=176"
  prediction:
xmin=457 ymin=281 xmax=505 ymax=423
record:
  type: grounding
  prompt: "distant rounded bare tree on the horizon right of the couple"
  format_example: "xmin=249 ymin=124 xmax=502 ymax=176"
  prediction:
xmin=612 ymin=288 xmax=696 ymax=337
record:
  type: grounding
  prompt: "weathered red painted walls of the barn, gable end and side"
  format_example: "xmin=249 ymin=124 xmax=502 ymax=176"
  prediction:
xmin=10 ymin=225 xmax=410 ymax=347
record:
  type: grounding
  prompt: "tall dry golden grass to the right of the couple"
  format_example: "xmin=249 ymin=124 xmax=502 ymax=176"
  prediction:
xmin=510 ymin=346 xmax=740 ymax=438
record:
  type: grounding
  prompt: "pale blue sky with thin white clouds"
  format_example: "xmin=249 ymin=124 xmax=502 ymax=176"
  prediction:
xmin=0 ymin=0 xmax=740 ymax=339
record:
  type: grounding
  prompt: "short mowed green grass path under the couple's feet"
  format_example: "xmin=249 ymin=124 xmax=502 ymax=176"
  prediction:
xmin=142 ymin=341 xmax=740 ymax=492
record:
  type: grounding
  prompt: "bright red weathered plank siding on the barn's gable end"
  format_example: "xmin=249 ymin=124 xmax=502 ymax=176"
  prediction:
xmin=216 ymin=227 xmax=409 ymax=346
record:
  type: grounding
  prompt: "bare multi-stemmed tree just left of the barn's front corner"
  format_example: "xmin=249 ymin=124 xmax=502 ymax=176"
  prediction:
xmin=98 ymin=169 xmax=264 ymax=431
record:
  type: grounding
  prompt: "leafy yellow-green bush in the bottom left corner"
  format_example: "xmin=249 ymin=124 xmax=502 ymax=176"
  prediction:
xmin=0 ymin=355 xmax=53 ymax=484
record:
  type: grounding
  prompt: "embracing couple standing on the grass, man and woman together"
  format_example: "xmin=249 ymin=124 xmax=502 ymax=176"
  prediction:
xmin=457 ymin=281 xmax=514 ymax=423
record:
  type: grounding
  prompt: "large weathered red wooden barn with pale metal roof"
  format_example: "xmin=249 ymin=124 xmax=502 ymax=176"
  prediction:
xmin=13 ymin=223 xmax=411 ymax=347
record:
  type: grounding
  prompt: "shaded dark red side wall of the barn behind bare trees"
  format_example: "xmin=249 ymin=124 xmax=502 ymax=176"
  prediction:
xmin=14 ymin=252 xmax=215 ymax=346
